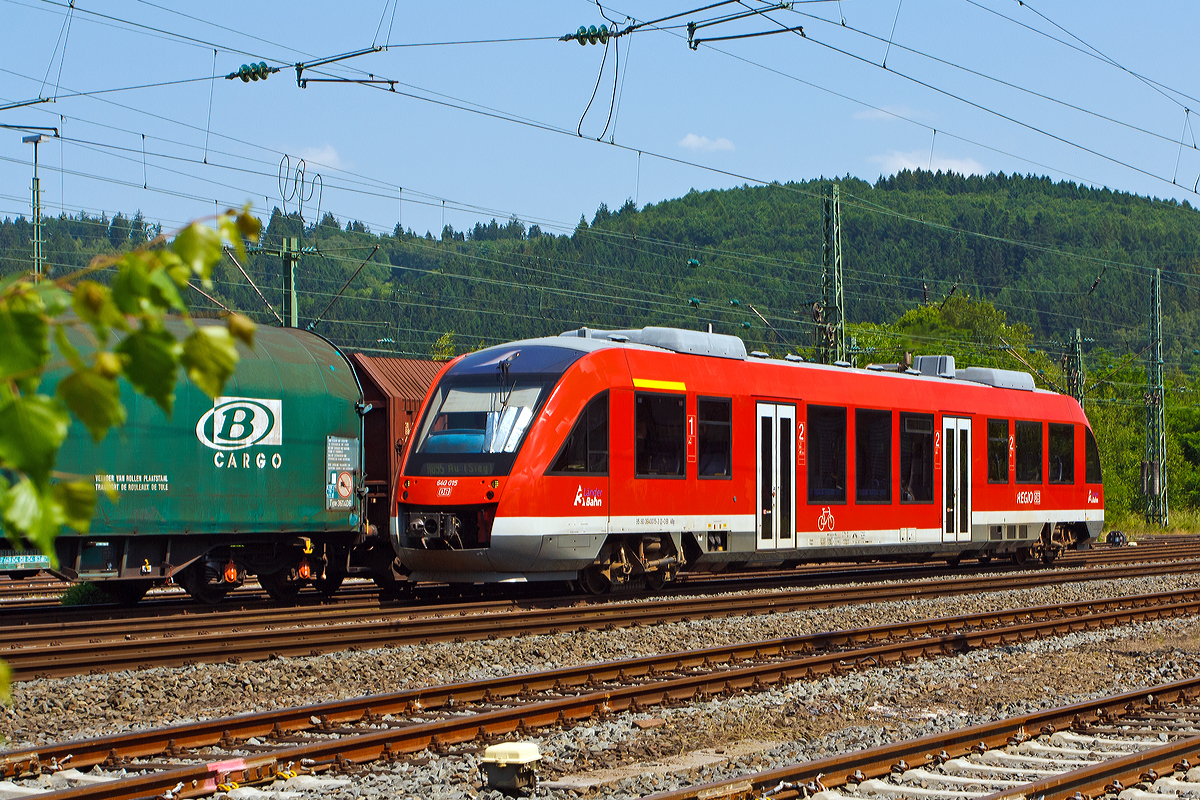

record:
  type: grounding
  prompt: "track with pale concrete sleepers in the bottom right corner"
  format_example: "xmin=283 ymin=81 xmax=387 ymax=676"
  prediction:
xmin=648 ymin=679 xmax=1200 ymax=800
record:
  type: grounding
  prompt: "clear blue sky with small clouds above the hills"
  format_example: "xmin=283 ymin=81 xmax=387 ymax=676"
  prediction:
xmin=0 ymin=0 xmax=1200 ymax=234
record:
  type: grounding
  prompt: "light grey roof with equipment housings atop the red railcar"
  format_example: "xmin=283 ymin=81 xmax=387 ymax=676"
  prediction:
xmin=458 ymin=326 xmax=1056 ymax=395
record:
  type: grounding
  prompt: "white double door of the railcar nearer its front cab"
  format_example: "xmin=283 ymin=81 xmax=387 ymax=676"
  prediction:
xmin=756 ymin=403 xmax=796 ymax=551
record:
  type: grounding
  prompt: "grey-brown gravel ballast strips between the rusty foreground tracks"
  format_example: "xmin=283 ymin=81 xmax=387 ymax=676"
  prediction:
xmin=0 ymin=576 xmax=1200 ymax=798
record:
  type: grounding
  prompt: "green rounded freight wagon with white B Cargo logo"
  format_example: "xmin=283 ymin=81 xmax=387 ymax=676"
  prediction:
xmin=30 ymin=320 xmax=395 ymax=602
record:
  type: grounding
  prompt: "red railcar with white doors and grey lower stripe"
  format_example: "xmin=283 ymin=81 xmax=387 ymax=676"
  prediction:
xmin=391 ymin=327 xmax=1104 ymax=591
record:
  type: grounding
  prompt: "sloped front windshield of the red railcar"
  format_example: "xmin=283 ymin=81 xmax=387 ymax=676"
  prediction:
xmin=404 ymin=347 xmax=578 ymax=476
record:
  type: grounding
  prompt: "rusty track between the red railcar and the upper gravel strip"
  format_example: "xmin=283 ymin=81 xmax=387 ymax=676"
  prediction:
xmin=7 ymin=561 xmax=1200 ymax=680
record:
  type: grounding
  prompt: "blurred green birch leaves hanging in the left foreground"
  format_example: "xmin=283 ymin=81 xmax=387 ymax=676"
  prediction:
xmin=0 ymin=209 xmax=259 ymax=563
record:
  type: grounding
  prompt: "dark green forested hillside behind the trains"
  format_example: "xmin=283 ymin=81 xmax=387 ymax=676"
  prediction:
xmin=0 ymin=170 xmax=1200 ymax=525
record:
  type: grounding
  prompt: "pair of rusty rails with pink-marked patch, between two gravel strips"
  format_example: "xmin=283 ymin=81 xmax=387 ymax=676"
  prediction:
xmin=7 ymin=590 xmax=1200 ymax=800
